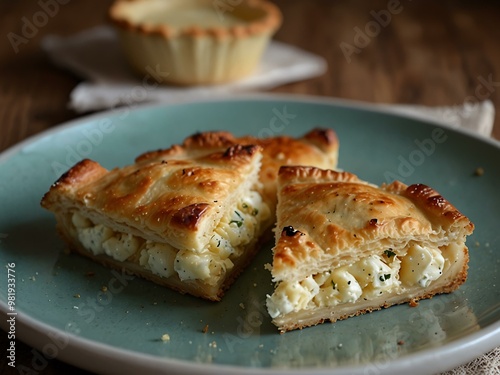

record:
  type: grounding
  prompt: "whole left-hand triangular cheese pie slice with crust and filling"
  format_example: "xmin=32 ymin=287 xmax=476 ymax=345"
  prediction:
xmin=41 ymin=145 xmax=271 ymax=300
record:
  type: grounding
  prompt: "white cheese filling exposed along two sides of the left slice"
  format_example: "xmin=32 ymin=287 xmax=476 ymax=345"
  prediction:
xmin=71 ymin=192 xmax=270 ymax=285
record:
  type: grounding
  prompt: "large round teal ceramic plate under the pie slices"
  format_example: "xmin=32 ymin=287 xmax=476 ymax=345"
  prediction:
xmin=0 ymin=96 xmax=500 ymax=374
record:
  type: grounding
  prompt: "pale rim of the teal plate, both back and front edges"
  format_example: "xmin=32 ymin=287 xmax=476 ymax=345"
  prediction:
xmin=0 ymin=93 xmax=500 ymax=375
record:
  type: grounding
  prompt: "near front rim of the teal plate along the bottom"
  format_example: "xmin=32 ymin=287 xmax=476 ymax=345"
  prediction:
xmin=0 ymin=300 xmax=500 ymax=375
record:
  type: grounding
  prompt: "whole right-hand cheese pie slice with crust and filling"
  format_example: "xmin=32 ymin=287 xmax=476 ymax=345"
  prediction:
xmin=267 ymin=166 xmax=474 ymax=332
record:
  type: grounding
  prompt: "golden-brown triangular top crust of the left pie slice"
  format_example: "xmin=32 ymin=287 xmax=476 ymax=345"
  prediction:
xmin=42 ymin=145 xmax=261 ymax=254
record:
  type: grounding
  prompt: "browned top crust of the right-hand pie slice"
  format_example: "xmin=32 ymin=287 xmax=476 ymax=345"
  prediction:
xmin=273 ymin=166 xmax=474 ymax=280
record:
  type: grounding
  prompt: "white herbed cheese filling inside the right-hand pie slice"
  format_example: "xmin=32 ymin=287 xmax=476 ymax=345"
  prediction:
xmin=267 ymin=243 xmax=445 ymax=319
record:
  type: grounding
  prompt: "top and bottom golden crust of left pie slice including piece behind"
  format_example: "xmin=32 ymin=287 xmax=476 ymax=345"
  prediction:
xmin=42 ymin=129 xmax=338 ymax=300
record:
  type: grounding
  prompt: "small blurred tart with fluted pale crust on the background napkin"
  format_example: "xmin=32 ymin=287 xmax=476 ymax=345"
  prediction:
xmin=109 ymin=0 xmax=282 ymax=85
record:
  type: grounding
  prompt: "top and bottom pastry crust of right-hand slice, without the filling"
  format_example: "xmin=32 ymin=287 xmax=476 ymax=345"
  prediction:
xmin=271 ymin=166 xmax=474 ymax=331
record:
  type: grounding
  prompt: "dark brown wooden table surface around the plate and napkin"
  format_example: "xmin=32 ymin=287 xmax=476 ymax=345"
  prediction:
xmin=0 ymin=0 xmax=500 ymax=374
